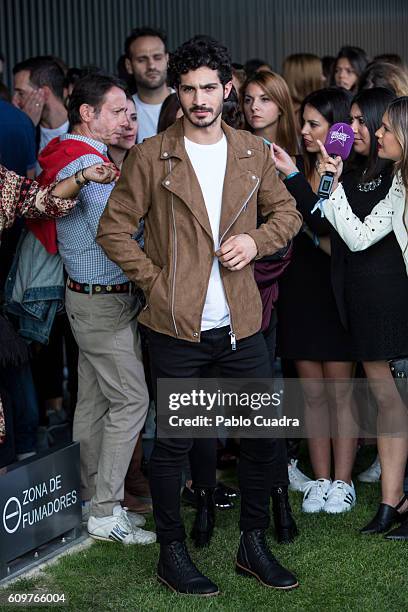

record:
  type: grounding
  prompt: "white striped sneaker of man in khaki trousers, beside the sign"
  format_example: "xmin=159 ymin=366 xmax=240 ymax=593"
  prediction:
xmin=88 ymin=506 xmax=156 ymax=544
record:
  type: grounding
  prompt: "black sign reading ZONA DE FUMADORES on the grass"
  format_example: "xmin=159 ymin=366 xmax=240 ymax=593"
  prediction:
xmin=0 ymin=442 xmax=81 ymax=562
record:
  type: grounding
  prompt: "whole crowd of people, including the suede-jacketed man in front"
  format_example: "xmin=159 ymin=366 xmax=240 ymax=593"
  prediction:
xmin=0 ymin=27 xmax=408 ymax=596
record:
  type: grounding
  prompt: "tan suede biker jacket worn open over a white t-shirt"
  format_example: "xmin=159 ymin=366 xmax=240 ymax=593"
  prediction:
xmin=97 ymin=119 xmax=302 ymax=342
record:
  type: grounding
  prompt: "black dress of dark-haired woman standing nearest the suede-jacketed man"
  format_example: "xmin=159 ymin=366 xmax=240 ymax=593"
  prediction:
xmin=277 ymin=158 xmax=355 ymax=361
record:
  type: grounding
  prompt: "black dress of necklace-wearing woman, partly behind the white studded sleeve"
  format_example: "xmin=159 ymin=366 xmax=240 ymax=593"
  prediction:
xmin=341 ymin=172 xmax=408 ymax=361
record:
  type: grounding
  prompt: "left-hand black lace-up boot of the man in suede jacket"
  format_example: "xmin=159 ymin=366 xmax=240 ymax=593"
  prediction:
xmin=157 ymin=541 xmax=219 ymax=597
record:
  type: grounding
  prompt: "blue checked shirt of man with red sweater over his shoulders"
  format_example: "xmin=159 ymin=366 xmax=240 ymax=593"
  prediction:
xmin=57 ymin=134 xmax=128 ymax=285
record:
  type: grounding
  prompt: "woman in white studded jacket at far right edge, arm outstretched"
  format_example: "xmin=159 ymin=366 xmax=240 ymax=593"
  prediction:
xmin=320 ymin=96 xmax=408 ymax=541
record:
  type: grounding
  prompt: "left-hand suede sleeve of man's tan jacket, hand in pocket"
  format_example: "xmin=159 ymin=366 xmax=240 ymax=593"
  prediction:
xmin=96 ymin=145 xmax=161 ymax=296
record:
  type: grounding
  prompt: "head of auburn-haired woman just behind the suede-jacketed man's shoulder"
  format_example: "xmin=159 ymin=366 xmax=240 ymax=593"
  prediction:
xmin=241 ymin=72 xmax=298 ymax=155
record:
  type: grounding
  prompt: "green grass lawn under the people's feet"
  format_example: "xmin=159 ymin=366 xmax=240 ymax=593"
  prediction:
xmin=0 ymin=447 xmax=408 ymax=612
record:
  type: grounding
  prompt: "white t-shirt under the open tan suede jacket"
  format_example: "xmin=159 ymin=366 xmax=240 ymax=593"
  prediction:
xmin=184 ymin=134 xmax=230 ymax=331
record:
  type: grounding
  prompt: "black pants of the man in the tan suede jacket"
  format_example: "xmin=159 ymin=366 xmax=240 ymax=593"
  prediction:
xmin=148 ymin=327 xmax=287 ymax=544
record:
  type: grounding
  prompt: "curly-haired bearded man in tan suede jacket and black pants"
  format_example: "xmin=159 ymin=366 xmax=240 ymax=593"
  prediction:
xmin=97 ymin=36 xmax=301 ymax=596
